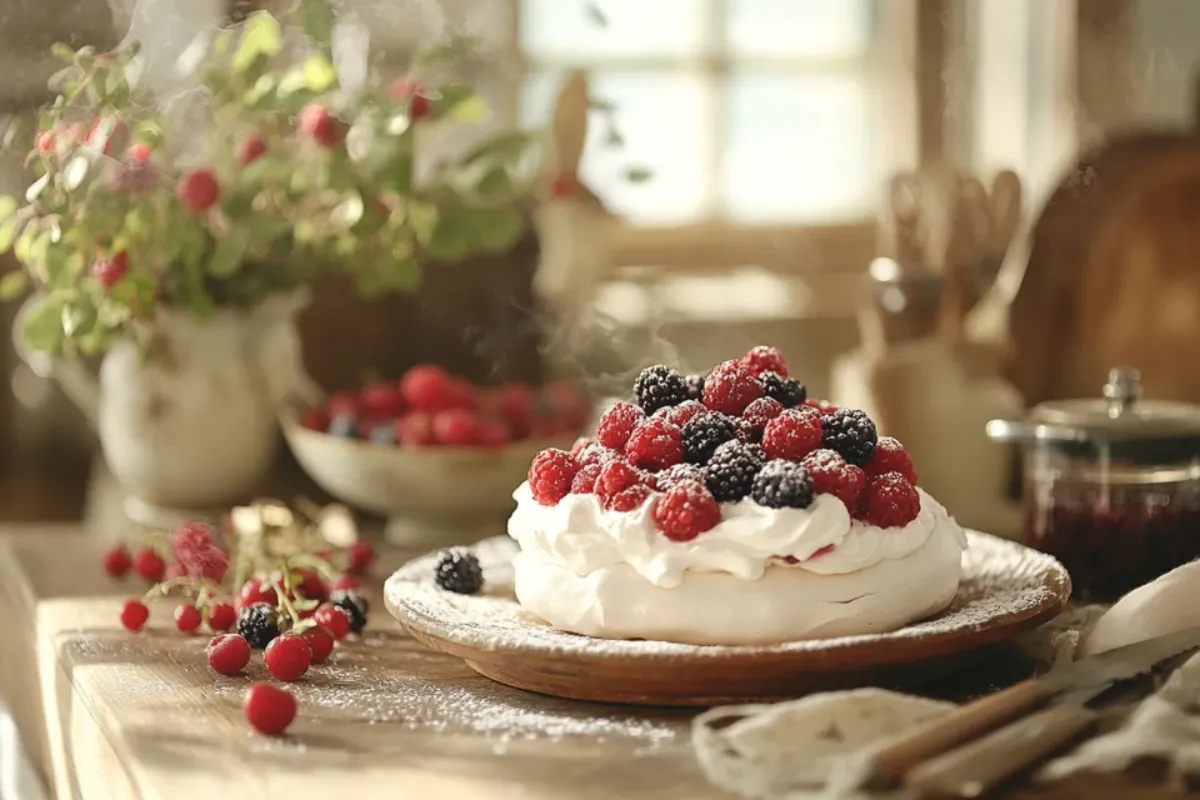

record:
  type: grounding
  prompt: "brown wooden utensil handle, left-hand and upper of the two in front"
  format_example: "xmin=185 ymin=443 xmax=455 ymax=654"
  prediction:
xmin=866 ymin=680 xmax=1050 ymax=789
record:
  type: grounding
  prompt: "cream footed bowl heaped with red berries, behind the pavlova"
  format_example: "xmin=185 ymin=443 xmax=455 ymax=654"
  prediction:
xmin=281 ymin=365 xmax=592 ymax=543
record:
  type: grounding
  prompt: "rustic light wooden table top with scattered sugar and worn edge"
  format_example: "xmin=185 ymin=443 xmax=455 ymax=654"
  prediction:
xmin=0 ymin=527 xmax=1172 ymax=800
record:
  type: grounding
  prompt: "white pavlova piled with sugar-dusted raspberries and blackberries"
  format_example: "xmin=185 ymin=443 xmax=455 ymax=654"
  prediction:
xmin=509 ymin=347 xmax=966 ymax=644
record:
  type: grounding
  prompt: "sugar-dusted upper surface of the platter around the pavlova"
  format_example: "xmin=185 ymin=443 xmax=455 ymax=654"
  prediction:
xmin=384 ymin=531 xmax=1069 ymax=660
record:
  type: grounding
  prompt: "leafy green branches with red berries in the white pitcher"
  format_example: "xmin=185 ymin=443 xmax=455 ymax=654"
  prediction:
xmin=0 ymin=0 xmax=534 ymax=354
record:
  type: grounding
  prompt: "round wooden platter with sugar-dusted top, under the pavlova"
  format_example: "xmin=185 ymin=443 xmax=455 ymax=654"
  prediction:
xmin=384 ymin=531 xmax=1070 ymax=706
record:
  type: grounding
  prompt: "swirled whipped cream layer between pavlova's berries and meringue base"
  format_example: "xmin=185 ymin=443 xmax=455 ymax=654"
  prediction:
xmin=509 ymin=483 xmax=966 ymax=588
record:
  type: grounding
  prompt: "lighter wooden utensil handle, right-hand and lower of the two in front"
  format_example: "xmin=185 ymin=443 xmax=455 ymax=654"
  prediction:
xmin=905 ymin=704 xmax=1099 ymax=798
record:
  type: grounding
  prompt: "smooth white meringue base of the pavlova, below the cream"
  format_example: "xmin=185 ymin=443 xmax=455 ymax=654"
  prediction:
xmin=512 ymin=527 xmax=962 ymax=645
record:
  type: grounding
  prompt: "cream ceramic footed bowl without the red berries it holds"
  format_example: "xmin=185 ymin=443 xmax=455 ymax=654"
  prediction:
xmin=280 ymin=415 xmax=577 ymax=543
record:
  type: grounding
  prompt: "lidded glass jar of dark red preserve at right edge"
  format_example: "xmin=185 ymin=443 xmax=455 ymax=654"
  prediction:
xmin=988 ymin=367 xmax=1200 ymax=602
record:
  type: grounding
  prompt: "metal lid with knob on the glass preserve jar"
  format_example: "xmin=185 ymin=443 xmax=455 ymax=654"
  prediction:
xmin=988 ymin=367 xmax=1200 ymax=463
